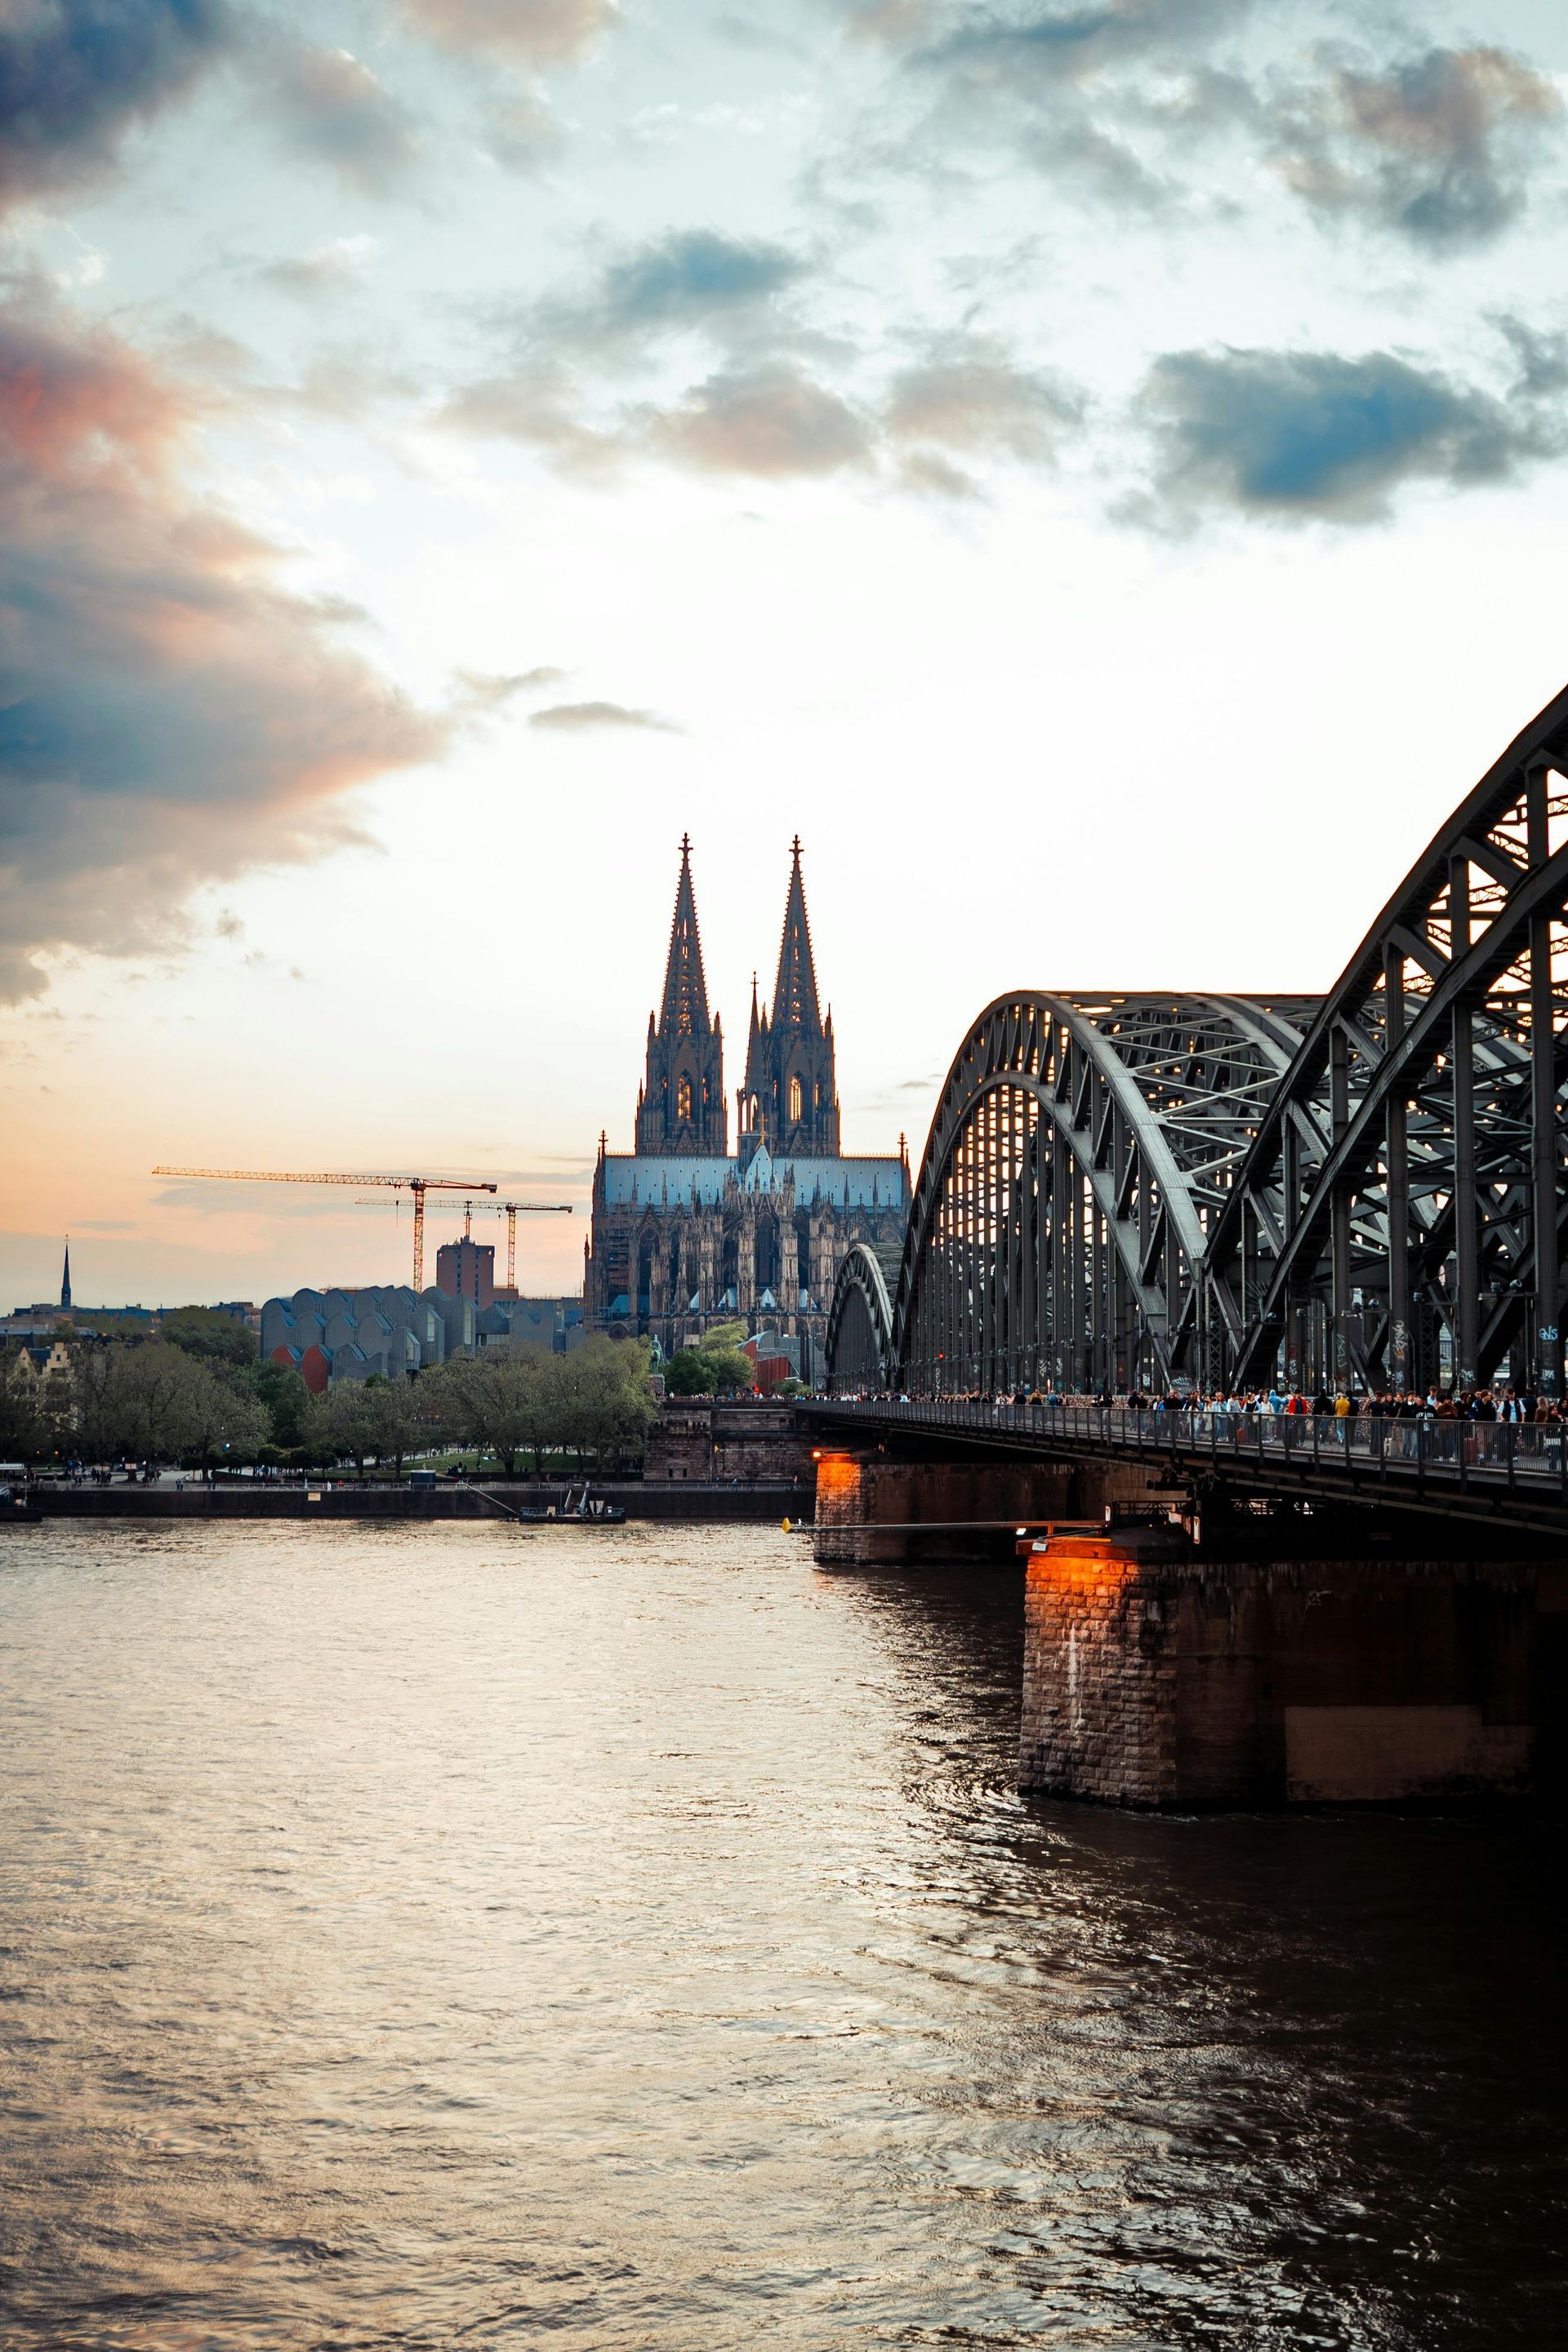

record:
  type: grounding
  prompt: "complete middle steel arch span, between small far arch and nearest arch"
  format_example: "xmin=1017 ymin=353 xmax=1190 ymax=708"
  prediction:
xmin=870 ymin=990 xmax=1316 ymax=1395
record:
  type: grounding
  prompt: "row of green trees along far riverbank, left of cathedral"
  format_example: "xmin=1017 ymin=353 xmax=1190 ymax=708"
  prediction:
xmin=0 ymin=1307 xmax=653 ymax=1475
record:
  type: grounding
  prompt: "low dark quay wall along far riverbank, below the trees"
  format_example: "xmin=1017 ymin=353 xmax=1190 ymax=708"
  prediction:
xmin=12 ymin=1480 xmax=813 ymax=1526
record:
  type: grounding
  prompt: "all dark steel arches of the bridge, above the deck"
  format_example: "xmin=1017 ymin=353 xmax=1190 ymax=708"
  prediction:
xmin=827 ymin=689 xmax=1568 ymax=1397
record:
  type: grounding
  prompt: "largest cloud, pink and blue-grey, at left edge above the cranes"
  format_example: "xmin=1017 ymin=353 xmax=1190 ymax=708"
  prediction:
xmin=0 ymin=292 xmax=447 ymax=997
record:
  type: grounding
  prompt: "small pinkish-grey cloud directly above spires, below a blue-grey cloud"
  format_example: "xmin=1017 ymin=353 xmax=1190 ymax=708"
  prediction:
xmin=647 ymin=364 xmax=872 ymax=480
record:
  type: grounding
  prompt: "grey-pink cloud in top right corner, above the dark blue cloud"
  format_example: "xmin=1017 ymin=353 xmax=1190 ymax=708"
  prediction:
xmin=1272 ymin=49 xmax=1563 ymax=249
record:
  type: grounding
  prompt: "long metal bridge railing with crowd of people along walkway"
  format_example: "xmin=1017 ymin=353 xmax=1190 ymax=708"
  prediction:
xmin=817 ymin=1397 xmax=1568 ymax=1499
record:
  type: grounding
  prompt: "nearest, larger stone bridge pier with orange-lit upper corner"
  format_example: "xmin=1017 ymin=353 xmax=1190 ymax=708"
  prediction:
xmin=1018 ymin=1519 xmax=1568 ymax=1809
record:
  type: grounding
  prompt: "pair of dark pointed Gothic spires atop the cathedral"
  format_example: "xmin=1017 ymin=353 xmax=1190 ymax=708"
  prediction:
xmin=637 ymin=835 xmax=840 ymax=1165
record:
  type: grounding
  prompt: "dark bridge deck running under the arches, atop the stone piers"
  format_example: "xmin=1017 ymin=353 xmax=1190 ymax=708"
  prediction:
xmin=802 ymin=1397 xmax=1568 ymax=1534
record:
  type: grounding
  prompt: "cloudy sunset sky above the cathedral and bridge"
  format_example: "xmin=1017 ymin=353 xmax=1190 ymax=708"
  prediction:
xmin=0 ymin=0 xmax=1568 ymax=1305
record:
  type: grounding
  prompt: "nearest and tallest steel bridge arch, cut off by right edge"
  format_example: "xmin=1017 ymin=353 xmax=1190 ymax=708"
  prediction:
xmin=1185 ymin=689 xmax=1568 ymax=1395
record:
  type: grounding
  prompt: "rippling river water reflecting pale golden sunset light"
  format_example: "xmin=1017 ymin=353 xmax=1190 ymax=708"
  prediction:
xmin=0 ymin=1521 xmax=1568 ymax=2352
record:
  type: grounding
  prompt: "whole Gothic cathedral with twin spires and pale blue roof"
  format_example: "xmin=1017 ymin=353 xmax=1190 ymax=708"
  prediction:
xmin=583 ymin=840 xmax=910 ymax=1381
